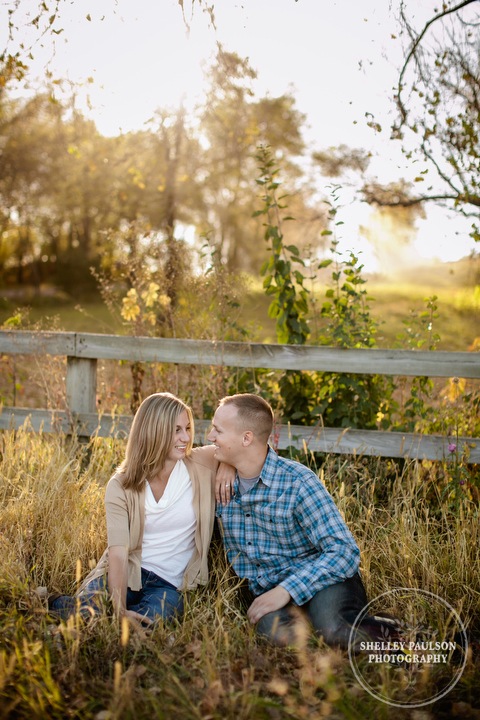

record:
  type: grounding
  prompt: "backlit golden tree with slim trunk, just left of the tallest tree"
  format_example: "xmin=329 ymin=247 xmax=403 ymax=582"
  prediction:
xmin=97 ymin=108 xmax=201 ymax=307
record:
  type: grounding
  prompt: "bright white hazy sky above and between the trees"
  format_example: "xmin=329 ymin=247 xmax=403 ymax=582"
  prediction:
xmin=0 ymin=0 xmax=478 ymax=270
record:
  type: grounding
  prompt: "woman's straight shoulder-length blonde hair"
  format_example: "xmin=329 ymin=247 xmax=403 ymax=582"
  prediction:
xmin=117 ymin=393 xmax=194 ymax=490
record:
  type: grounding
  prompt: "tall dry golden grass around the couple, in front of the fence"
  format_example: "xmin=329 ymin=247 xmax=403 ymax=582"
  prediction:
xmin=0 ymin=429 xmax=480 ymax=720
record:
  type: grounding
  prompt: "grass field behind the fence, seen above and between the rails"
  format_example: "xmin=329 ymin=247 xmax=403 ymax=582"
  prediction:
xmin=0 ymin=261 xmax=480 ymax=424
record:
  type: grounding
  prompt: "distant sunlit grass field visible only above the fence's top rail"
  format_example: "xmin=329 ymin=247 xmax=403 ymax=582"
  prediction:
xmin=0 ymin=258 xmax=480 ymax=350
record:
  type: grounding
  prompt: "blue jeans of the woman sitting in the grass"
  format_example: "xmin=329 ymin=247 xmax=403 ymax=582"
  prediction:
xmin=49 ymin=568 xmax=183 ymax=621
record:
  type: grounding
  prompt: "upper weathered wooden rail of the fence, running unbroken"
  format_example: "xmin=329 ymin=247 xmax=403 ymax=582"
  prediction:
xmin=0 ymin=330 xmax=480 ymax=378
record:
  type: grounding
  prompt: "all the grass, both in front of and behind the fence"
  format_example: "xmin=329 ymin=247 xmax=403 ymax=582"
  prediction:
xmin=0 ymin=258 xmax=480 ymax=720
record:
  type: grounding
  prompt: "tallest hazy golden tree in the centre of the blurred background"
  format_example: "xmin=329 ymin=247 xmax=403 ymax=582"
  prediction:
xmin=201 ymin=47 xmax=312 ymax=271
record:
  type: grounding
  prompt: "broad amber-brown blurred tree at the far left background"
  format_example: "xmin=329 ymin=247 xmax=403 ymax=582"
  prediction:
xmin=0 ymin=92 xmax=126 ymax=287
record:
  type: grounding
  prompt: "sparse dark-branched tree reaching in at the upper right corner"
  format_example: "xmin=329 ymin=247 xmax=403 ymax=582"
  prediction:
xmin=364 ymin=0 xmax=480 ymax=240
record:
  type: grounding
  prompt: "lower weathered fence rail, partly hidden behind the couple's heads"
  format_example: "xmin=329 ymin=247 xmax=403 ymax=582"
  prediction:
xmin=0 ymin=407 xmax=480 ymax=463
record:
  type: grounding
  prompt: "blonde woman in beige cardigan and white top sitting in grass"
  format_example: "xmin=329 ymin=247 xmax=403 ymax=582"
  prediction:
xmin=48 ymin=393 xmax=235 ymax=624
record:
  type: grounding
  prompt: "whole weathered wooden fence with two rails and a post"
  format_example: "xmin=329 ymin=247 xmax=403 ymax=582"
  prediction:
xmin=0 ymin=330 xmax=480 ymax=463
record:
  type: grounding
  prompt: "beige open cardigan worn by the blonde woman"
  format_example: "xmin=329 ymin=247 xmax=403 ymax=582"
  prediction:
xmin=79 ymin=446 xmax=218 ymax=593
